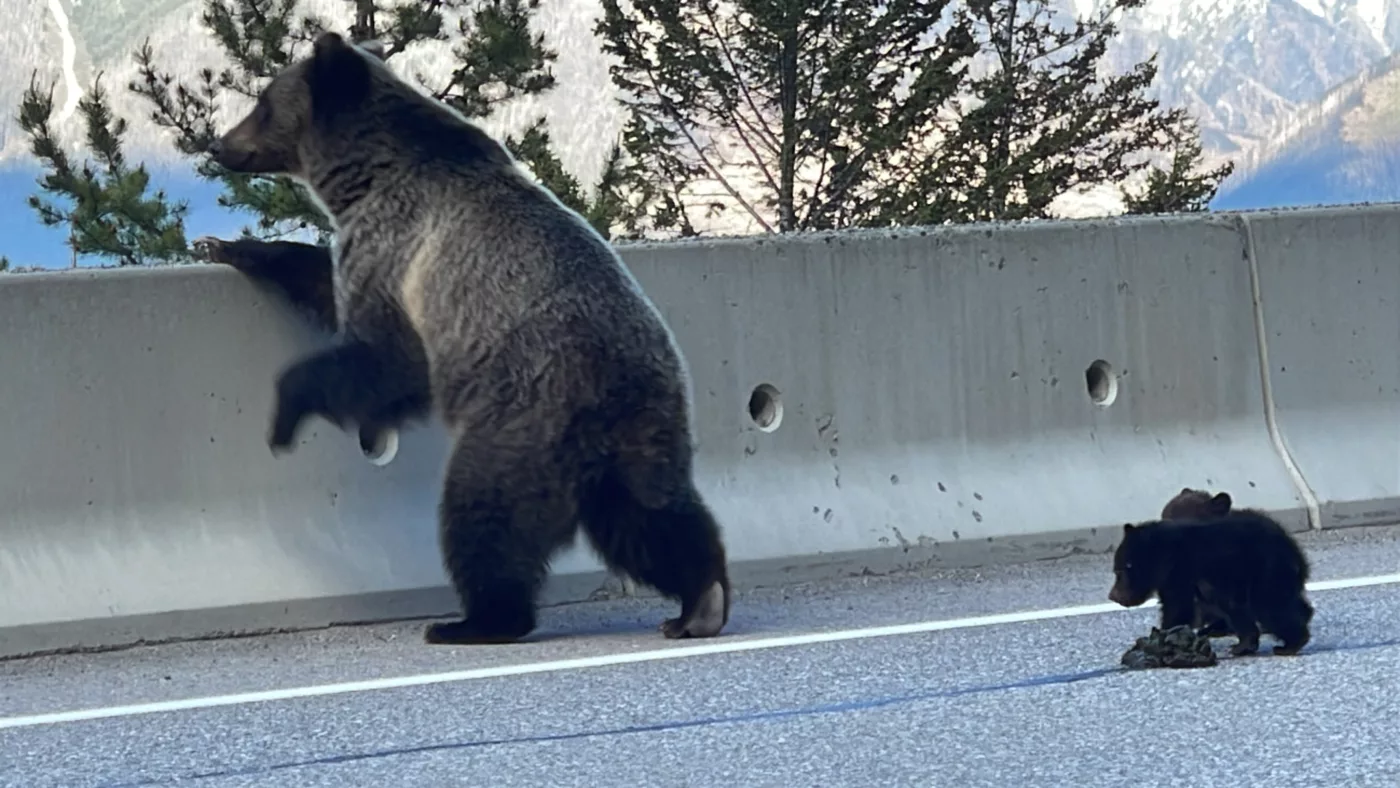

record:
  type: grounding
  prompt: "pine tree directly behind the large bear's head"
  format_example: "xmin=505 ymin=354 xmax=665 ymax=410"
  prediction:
xmin=130 ymin=0 xmax=632 ymax=244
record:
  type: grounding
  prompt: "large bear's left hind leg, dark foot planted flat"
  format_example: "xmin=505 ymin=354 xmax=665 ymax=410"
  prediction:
xmin=424 ymin=435 xmax=578 ymax=645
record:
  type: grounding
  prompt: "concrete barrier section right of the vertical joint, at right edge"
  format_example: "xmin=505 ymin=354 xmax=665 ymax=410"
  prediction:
xmin=1240 ymin=206 xmax=1400 ymax=528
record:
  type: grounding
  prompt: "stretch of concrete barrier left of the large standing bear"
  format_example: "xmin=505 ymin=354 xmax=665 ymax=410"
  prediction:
xmin=0 ymin=266 xmax=451 ymax=654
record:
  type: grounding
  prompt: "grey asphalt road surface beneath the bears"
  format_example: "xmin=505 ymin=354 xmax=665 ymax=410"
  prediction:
xmin=0 ymin=529 xmax=1400 ymax=788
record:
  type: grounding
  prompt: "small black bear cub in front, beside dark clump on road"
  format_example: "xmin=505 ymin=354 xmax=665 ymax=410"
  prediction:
xmin=1109 ymin=490 xmax=1313 ymax=656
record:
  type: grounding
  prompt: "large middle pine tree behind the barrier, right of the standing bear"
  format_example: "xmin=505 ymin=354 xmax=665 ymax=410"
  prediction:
xmin=596 ymin=0 xmax=974 ymax=235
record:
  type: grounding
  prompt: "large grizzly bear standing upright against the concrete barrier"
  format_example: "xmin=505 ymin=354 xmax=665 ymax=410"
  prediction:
xmin=210 ymin=32 xmax=731 ymax=644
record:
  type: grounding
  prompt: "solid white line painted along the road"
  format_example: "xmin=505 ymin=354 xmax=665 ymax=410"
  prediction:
xmin=0 ymin=574 xmax=1400 ymax=728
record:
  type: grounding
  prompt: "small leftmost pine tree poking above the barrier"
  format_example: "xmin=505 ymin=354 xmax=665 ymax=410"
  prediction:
xmin=20 ymin=74 xmax=190 ymax=266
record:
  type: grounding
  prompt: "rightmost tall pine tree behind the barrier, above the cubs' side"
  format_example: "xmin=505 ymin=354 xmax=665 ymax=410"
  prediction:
xmin=897 ymin=0 xmax=1218 ymax=224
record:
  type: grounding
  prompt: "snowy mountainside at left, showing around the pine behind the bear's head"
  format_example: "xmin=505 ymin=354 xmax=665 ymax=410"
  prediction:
xmin=0 ymin=0 xmax=622 ymax=188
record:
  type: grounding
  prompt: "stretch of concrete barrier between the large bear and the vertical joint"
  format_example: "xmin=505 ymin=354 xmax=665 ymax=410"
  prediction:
xmin=626 ymin=218 xmax=1306 ymax=571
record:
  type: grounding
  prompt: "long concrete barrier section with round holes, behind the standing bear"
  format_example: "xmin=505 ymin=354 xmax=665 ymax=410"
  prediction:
xmin=0 ymin=208 xmax=1355 ymax=655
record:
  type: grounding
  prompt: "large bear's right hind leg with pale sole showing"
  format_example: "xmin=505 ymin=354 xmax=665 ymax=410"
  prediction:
xmin=582 ymin=479 xmax=731 ymax=638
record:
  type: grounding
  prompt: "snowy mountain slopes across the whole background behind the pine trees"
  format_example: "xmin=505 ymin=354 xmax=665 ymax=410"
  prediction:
xmin=0 ymin=0 xmax=1400 ymax=213
